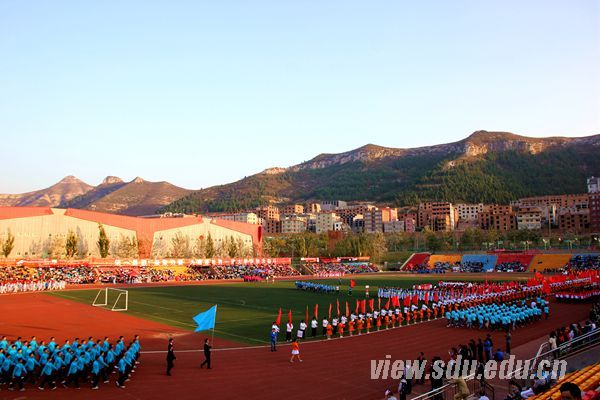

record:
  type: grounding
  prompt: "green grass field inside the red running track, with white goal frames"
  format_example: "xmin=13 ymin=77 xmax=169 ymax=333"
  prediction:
xmin=49 ymin=274 xmax=524 ymax=345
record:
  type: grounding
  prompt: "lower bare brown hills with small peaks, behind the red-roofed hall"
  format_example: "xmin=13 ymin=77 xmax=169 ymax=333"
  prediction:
xmin=0 ymin=176 xmax=191 ymax=215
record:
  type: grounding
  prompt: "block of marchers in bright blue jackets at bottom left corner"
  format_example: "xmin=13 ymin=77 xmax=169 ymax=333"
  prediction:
xmin=0 ymin=335 xmax=141 ymax=391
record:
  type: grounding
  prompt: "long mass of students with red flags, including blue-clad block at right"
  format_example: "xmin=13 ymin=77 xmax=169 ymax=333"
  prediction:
xmin=280 ymin=279 xmax=595 ymax=342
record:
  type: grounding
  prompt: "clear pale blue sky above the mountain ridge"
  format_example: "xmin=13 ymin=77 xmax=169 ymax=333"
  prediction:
xmin=0 ymin=0 xmax=600 ymax=193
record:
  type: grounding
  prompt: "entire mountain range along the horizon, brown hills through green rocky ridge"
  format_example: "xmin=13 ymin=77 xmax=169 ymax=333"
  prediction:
xmin=0 ymin=131 xmax=600 ymax=215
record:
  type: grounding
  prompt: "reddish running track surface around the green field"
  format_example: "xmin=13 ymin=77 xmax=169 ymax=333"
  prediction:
xmin=0 ymin=293 xmax=589 ymax=400
